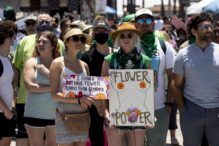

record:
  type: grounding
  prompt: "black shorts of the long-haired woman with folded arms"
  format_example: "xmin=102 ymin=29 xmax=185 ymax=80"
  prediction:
xmin=24 ymin=117 xmax=55 ymax=128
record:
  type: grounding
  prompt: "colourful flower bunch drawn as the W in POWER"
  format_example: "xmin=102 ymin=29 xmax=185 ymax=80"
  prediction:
xmin=126 ymin=107 xmax=141 ymax=123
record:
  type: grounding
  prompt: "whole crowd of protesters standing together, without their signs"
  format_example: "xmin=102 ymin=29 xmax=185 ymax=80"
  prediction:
xmin=0 ymin=4 xmax=219 ymax=146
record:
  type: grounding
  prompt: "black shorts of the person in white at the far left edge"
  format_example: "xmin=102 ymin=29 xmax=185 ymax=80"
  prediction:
xmin=0 ymin=113 xmax=16 ymax=139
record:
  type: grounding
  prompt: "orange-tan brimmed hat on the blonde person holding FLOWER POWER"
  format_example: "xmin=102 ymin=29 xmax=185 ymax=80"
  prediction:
xmin=111 ymin=22 xmax=143 ymax=40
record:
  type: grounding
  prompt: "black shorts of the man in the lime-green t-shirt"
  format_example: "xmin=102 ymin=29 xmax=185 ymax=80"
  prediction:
xmin=16 ymin=104 xmax=28 ymax=138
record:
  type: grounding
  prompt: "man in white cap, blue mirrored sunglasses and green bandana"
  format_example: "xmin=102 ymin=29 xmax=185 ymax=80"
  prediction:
xmin=135 ymin=8 xmax=175 ymax=146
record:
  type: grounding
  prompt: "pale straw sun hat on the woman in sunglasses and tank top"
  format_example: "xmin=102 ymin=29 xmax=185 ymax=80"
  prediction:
xmin=64 ymin=28 xmax=92 ymax=44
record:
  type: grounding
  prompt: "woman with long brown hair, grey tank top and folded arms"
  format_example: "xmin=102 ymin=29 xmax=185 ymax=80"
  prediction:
xmin=24 ymin=31 xmax=61 ymax=146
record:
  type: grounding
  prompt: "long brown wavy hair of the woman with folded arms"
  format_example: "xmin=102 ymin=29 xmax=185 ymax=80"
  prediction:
xmin=33 ymin=31 xmax=61 ymax=58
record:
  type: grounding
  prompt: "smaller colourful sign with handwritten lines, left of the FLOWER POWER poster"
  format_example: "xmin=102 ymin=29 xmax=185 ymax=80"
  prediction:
xmin=62 ymin=75 xmax=109 ymax=99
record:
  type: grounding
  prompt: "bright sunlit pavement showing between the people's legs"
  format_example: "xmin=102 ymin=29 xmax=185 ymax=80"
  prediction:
xmin=11 ymin=114 xmax=183 ymax=146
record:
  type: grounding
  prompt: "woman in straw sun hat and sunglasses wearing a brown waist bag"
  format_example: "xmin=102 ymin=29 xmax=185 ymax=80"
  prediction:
xmin=50 ymin=28 xmax=93 ymax=146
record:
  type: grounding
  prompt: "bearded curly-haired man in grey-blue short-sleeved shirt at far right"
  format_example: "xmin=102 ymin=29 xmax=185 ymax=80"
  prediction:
xmin=173 ymin=13 xmax=219 ymax=146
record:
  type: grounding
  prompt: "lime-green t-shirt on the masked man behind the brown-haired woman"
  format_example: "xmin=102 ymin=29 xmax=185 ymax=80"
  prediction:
xmin=12 ymin=34 xmax=65 ymax=104
